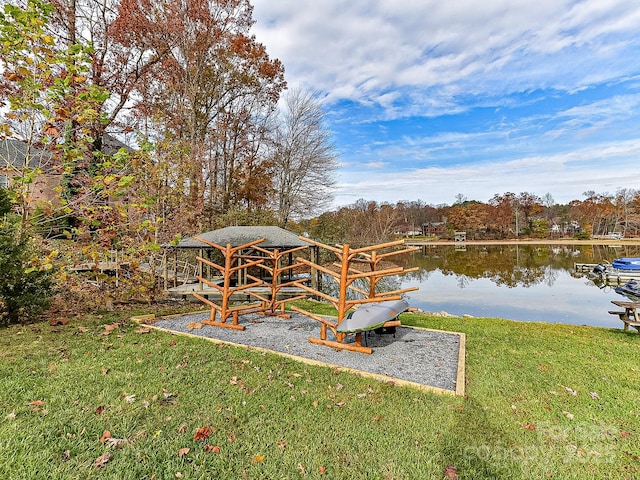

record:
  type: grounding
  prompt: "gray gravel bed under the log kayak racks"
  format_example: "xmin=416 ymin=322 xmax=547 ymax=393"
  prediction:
xmin=154 ymin=312 xmax=464 ymax=392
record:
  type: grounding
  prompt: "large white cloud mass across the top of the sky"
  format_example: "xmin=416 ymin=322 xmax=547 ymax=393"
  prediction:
xmin=254 ymin=0 xmax=640 ymax=115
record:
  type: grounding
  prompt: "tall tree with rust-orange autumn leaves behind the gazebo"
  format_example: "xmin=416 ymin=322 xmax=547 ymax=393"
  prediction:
xmin=125 ymin=0 xmax=285 ymax=221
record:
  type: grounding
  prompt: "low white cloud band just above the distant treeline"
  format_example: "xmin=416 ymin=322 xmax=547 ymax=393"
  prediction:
xmin=335 ymin=140 xmax=640 ymax=205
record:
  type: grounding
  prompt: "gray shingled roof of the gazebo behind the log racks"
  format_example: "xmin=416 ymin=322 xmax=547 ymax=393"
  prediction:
xmin=166 ymin=226 xmax=310 ymax=249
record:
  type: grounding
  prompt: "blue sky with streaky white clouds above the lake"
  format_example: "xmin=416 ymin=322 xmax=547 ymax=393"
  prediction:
xmin=252 ymin=0 xmax=640 ymax=206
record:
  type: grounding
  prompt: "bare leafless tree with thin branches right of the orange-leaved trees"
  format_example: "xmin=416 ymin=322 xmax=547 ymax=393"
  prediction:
xmin=273 ymin=89 xmax=337 ymax=226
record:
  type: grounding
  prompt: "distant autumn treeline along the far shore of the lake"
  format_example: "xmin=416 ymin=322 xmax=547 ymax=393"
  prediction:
xmin=300 ymin=189 xmax=640 ymax=244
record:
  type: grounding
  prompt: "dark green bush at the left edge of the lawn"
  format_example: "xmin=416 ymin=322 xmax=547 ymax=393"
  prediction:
xmin=0 ymin=190 xmax=54 ymax=326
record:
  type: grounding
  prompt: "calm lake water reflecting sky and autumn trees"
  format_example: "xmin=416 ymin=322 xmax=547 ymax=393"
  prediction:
xmin=401 ymin=245 xmax=640 ymax=328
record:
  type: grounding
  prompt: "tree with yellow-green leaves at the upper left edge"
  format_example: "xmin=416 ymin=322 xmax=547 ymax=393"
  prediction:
xmin=0 ymin=0 xmax=108 ymax=228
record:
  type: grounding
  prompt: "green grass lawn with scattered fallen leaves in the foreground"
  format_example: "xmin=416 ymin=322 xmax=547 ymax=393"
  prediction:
xmin=0 ymin=304 xmax=640 ymax=479
